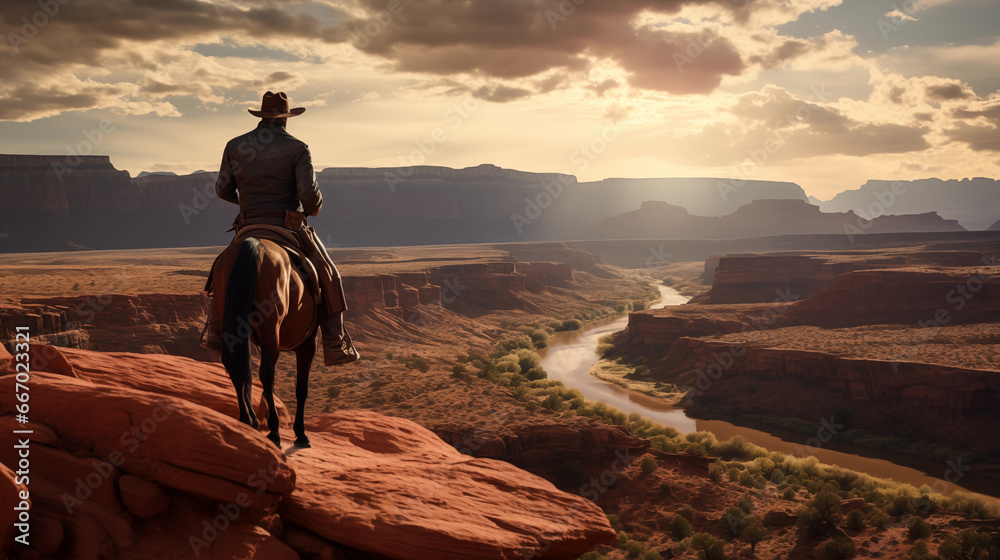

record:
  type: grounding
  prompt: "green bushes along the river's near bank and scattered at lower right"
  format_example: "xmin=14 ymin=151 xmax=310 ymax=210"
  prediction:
xmin=470 ymin=334 xmax=1000 ymax=560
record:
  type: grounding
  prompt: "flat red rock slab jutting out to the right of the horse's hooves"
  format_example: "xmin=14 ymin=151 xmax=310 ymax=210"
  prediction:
xmin=280 ymin=411 xmax=613 ymax=560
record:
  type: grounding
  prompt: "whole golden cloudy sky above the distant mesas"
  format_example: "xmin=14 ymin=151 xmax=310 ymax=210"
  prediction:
xmin=0 ymin=0 xmax=1000 ymax=200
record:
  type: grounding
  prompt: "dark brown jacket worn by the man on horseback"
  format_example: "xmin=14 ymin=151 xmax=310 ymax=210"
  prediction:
xmin=215 ymin=120 xmax=323 ymax=221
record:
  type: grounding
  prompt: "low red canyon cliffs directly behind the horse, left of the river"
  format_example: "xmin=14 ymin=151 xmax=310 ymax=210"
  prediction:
xmin=0 ymin=261 xmax=573 ymax=359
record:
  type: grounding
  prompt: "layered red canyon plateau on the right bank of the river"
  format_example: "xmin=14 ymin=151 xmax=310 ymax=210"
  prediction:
xmin=614 ymin=238 xmax=1000 ymax=462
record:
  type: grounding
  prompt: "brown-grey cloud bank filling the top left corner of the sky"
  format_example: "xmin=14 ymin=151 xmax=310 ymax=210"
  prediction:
xmin=0 ymin=0 xmax=346 ymax=121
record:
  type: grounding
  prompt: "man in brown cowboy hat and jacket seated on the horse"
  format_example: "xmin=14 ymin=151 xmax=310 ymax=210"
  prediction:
xmin=203 ymin=91 xmax=360 ymax=366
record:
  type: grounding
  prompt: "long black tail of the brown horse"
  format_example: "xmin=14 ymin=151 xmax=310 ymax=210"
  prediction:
xmin=222 ymin=237 xmax=260 ymax=387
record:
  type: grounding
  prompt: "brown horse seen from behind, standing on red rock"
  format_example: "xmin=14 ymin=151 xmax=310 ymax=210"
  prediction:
xmin=212 ymin=237 xmax=317 ymax=448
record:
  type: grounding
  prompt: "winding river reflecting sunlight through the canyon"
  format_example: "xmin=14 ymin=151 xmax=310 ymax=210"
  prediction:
xmin=538 ymin=285 xmax=1000 ymax=497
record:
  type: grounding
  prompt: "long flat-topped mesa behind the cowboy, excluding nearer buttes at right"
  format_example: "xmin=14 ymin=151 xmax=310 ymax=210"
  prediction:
xmin=0 ymin=155 xmax=804 ymax=252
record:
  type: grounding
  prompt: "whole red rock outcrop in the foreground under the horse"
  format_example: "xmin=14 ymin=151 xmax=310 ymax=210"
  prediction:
xmin=0 ymin=347 xmax=616 ymax=560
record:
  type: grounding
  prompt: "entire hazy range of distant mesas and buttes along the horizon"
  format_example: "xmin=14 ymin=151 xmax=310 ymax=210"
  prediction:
xmin=0 ymin=155 xmax=996 ymax=252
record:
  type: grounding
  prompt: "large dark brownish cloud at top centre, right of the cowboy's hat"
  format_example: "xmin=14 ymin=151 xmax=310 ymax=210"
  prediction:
xmin=344 ymin=0 xmax=830 ymax=94
